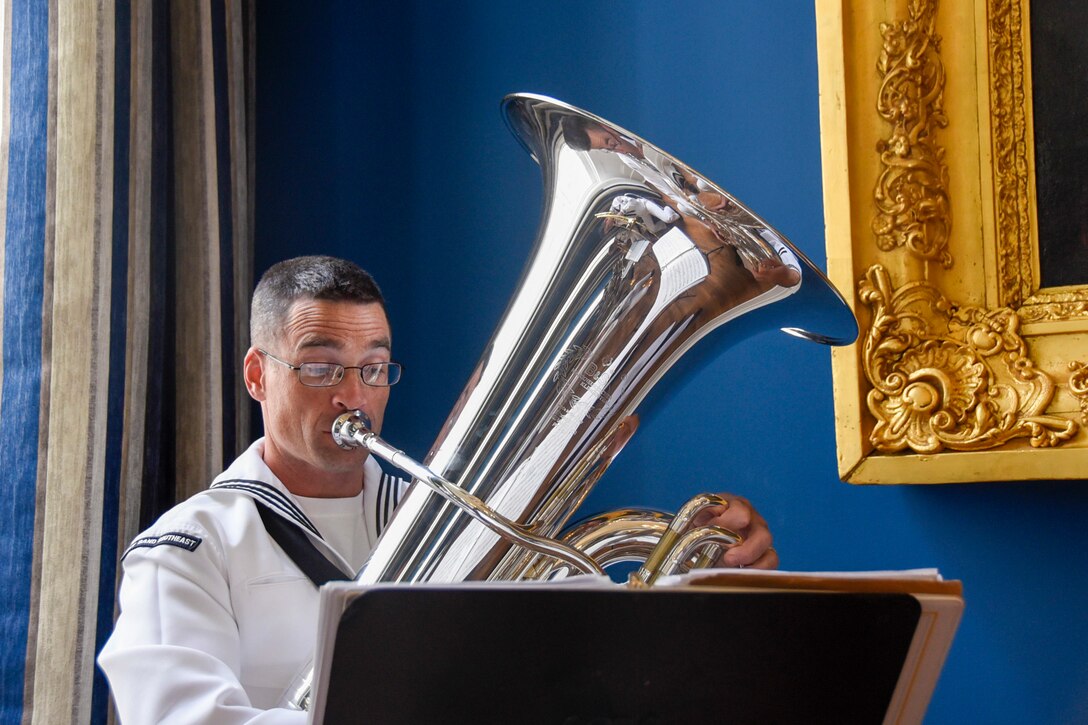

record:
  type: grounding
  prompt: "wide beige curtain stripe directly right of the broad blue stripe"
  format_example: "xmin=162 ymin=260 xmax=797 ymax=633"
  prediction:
xmin=27 ymin=2 xmax=114 ymax=723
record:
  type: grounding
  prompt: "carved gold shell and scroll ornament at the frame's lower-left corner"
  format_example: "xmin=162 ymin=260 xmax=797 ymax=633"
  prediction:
xmin=858 ymin=265 xmax=1077 ymax=453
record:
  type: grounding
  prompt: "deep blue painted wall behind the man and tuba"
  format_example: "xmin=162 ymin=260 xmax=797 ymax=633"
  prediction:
xmin=257 ymin=0 xmax=1088 ymax=723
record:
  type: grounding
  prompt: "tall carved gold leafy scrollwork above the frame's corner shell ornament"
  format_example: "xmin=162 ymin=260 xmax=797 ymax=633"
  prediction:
xmin=873 ymin=0 xmax=952 ymax=268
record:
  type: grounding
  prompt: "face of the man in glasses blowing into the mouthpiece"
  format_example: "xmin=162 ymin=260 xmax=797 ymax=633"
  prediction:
xmin=245 ymin=299 xmax=391 ymax=495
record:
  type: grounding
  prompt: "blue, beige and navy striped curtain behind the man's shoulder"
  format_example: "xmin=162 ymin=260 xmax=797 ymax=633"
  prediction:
xmin=0 ymin=0 xmax=254 ymax=724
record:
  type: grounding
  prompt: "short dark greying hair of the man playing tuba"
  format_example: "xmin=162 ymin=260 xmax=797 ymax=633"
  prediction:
xmin=249 ymin=255 xmax=385 ymax=345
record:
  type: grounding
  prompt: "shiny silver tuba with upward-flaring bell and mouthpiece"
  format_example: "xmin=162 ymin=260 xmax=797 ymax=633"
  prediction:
xmin=282 ymin=94 xmax=857 ymax=705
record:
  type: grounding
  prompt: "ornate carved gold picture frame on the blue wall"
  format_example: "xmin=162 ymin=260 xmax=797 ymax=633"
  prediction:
xmin=816 ymin=0 xmax=1088 ymax=483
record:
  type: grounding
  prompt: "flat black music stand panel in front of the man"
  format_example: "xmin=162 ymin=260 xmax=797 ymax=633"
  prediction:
xmin=308 ymin=585 xmax=953 ymax=724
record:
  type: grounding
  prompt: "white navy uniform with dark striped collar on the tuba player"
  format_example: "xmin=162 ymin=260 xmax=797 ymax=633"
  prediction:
xmin=98 ymin=439 xmax=408 ymax=725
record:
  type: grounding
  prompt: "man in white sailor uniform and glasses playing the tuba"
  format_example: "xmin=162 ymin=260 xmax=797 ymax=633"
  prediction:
xmin=99 ymin=252 xmax=778 ymax=723
